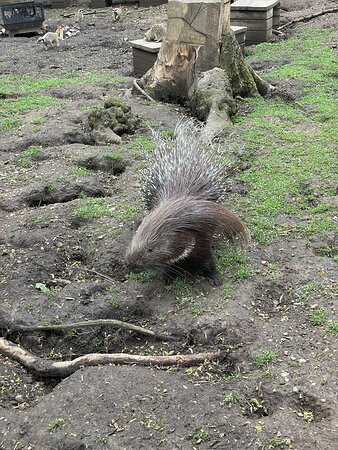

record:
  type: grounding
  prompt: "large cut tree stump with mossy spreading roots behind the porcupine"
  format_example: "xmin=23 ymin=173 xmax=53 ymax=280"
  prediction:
xmin=140 ymin=0 xmax=271 ymax=139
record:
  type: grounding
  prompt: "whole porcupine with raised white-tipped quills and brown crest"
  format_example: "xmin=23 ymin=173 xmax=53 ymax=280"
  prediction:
xmin=126 ymin=120 xmax=249 ymax=286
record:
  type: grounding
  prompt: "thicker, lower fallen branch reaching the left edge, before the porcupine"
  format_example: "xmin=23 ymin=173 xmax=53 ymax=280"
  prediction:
xmin=0 ymin=338 xmax=223 ymax=378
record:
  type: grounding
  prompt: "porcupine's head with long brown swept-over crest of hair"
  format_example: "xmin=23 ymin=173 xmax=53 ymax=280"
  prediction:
xmin=125 ymin=197 xmax=249 ymax=272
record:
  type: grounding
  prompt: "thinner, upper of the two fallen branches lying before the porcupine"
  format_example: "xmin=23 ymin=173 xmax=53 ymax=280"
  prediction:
xmin=11 ymin=319 xmax=175 ymax=340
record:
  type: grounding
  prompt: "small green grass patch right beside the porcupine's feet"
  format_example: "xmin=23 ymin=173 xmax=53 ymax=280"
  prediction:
xmin=216 ymin=244 xmax=253 ymax=281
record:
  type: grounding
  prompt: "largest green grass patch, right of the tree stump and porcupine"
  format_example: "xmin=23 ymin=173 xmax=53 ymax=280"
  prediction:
xmin=235 ymin=27 xmax=338 ymax=244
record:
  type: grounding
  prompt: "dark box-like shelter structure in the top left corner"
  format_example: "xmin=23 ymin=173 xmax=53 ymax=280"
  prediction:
xmin=0 ymin=0 xmax=45 ymax=36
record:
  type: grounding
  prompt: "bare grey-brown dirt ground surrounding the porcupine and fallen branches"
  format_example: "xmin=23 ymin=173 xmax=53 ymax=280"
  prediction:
xmin=0 ymin=0 xmax=338 ymax=450
